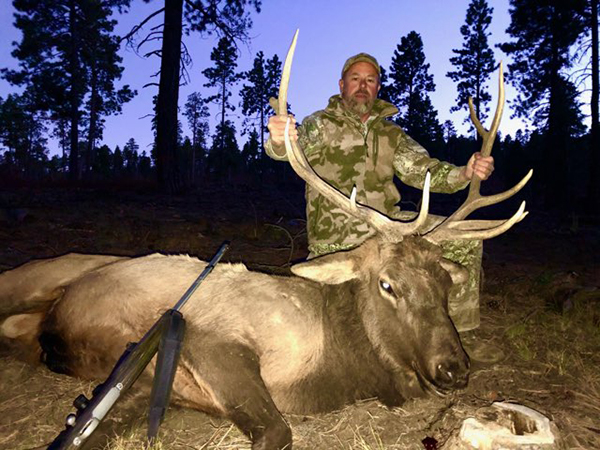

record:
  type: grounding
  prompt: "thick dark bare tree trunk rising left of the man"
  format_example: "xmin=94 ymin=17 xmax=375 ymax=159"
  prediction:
xmin=156 ymin=0 xmax=185 ymax=193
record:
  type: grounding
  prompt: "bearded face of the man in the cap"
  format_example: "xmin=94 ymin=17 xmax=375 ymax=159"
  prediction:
xmin=340 ymin=61 xmax=380 ymax=116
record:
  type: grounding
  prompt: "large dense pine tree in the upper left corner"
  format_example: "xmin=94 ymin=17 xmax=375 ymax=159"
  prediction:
xmin=3 ymin=0 xmax=130 ymax=178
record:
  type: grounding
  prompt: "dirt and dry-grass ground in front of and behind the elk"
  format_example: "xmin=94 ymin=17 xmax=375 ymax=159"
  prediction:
xmin=0 ymin=188 xmax=600 ymax=450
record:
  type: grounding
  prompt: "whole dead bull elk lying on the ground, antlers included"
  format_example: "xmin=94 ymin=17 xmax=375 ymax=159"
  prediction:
xmin=0 ymin=32 xmax=526 ymax=449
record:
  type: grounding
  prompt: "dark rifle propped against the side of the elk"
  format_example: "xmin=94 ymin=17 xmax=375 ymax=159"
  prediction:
xmin=48 ymin=242 xmax=229 ymax=450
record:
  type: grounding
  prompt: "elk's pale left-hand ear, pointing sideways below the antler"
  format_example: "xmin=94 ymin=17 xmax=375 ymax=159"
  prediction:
xmin=291 ymin=252 xmax=359 ymax=284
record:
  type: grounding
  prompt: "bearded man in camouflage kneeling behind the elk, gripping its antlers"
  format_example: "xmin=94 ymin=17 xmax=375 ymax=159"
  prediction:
xmin=265 ymin=53 xmax=501 ymax=362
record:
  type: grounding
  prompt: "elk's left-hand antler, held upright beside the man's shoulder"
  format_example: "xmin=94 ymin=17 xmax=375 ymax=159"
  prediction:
xmin=277 ymin=30 xmax=430 ymax=242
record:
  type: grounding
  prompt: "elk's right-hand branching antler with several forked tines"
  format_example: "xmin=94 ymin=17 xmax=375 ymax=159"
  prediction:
xmin=426 ymin=63 xmax=533 ymax=242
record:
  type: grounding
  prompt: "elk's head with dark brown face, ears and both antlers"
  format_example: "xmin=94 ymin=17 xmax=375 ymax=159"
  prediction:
xmin=278 ymin=32 xmax=531 ymax=397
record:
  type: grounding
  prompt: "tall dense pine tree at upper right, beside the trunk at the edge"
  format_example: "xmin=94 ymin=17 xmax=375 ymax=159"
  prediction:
xmin=500 ymin=0 xmax=584 ymax=213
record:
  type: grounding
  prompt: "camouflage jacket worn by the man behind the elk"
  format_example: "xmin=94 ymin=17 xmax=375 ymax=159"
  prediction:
xmin=265 ymin=95 xmax=468 ymax=255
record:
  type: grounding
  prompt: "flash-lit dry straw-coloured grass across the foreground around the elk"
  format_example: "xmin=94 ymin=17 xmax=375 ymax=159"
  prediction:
xmin=0 ymin=280 xmax=600 ymax=450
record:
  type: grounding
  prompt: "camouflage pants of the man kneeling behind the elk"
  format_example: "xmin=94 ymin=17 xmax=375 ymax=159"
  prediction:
xmin=308 ymin=211 xmax=483 ymax=332
